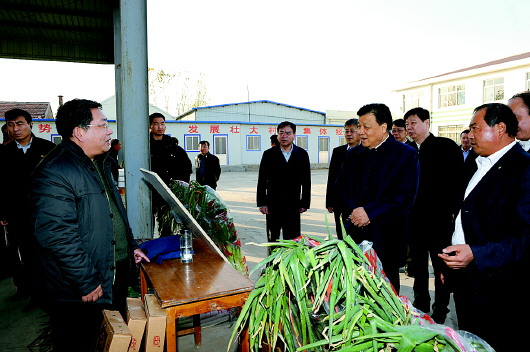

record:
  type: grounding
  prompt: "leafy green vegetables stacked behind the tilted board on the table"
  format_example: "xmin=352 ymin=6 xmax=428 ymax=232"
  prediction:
xmin=158 ymin=181 xmax=248 ymax=276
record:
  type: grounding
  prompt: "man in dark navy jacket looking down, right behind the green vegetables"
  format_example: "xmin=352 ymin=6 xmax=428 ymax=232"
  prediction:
xmin=336 ymin=104 xmax=418 ymax=293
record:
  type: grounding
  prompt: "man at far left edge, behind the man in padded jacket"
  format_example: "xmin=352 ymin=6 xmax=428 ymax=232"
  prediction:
xmin=0 ymin=109 xmax=55 ymax=300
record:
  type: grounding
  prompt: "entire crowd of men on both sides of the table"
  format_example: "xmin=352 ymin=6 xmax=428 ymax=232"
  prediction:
xmin=0 ymin=92 xmax=530 ymax=351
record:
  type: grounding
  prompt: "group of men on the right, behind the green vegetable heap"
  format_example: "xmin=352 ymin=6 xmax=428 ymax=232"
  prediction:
xmin=257 ymin=92 xmax=530 ymax=351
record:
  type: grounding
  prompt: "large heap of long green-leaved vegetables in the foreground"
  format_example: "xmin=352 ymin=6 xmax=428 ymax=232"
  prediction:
xmin=228 ymin=236 xmax=490 ymax=352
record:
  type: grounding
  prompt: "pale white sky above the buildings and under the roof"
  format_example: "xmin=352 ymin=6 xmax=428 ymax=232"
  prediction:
xmin=0 ymin=0 xmax=530 ymax=117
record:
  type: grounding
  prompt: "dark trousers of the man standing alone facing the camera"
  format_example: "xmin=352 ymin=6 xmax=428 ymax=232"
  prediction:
xmin=266 ymin=207 xmax=300 ymax=242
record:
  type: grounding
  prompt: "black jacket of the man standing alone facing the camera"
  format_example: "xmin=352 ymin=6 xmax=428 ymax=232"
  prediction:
xmin=257 ymin=144 xmax=311 ymax=209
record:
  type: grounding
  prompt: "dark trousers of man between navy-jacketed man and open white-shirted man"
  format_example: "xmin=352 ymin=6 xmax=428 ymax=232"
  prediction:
xmin=410 ymin=241 xmax=451 ymax=314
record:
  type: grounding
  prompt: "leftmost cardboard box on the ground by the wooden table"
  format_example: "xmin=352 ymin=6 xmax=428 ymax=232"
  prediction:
xmin=96 ymin=309 xmax=132 ymax=352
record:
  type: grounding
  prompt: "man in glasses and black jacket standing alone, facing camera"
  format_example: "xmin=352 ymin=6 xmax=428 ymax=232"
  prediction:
xmin=257 ymin=121 xmax=311 ymax=242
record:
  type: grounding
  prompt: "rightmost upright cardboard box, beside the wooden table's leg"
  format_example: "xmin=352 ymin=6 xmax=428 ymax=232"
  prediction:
xmin=144 ymin=294 xmax=166 ymax=352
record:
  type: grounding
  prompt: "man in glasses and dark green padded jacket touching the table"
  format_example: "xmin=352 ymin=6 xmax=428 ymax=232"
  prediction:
xmin=30 ymin=99 xmax=149 ymax=351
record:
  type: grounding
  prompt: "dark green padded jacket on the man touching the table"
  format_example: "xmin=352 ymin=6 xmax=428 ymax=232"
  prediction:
xmin=30 ymin=140 xmax=137 ymax=303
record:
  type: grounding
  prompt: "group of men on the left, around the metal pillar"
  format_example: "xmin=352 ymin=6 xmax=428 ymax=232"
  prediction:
xmin=0 ymin=104 xmax=220 ymax=351
